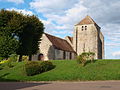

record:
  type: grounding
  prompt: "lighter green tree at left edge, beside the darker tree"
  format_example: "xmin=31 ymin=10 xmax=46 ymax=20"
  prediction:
xmin=0 ymin=9 xmax=18 ymax=58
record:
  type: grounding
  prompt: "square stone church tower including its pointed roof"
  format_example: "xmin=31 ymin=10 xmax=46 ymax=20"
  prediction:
xmin=73 ymin=16 xmax=104 ymax=59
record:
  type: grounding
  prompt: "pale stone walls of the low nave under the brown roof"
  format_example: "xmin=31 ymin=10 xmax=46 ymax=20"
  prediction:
xmin=32 ymin=34 xmax=75 ymax=61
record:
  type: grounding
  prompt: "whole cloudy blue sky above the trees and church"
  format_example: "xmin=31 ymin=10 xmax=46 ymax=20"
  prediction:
xmin=0 ymin=0 xmax=120 ymax=59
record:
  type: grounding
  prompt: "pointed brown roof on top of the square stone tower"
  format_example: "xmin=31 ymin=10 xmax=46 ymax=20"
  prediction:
xmin=76 ymin=15 xmax=99 ymax=27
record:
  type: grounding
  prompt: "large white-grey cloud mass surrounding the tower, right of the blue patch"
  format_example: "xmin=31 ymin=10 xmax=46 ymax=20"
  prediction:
xmin=30 ymin=0 xmax=120 ymax=59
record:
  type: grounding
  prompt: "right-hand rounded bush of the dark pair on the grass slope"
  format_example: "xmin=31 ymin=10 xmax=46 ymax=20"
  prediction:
xmin=40 ymin=61 xmax=55 ymax=72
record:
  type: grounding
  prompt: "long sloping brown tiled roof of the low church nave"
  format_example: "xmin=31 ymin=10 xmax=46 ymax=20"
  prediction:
xmin=45 ymin=33 xmax=75 ymax=52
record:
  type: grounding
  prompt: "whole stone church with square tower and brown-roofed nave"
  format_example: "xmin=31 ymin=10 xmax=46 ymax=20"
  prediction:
xmin=33 ymin=16 xmax=104 ymax=60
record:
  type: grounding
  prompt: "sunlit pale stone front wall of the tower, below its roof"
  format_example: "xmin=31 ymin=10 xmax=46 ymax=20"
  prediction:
xmin=73 ymin=24 xmax=104 ymax=59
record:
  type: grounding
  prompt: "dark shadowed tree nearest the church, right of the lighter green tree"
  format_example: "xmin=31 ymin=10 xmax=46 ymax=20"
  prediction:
xmin=18 ymin=15 xmax=44 ymax=61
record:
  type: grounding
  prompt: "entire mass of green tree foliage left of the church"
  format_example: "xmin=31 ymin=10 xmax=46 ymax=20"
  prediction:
xmin=0 ymin=10 xmax=44 ymax=61
